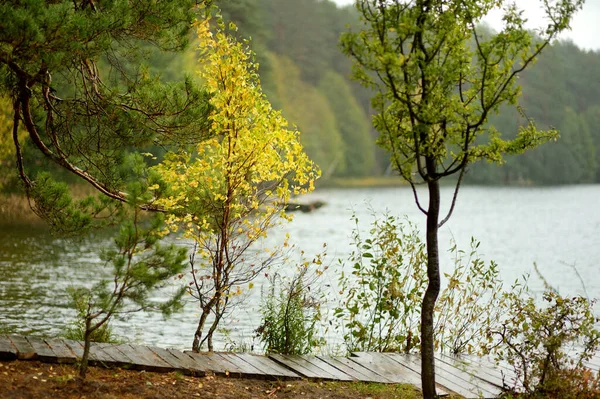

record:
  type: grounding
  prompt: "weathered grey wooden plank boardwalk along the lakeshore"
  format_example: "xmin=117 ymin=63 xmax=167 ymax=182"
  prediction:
xmin=0 ymin=335 xmax=600 ymax=399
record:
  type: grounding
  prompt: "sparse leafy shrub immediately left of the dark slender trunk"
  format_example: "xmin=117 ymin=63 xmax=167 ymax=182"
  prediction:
xmin=335 ymin=215 xmax=427 ymax=352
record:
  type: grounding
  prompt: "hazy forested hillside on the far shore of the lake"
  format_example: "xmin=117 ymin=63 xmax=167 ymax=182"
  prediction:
xmin=0 ymin=0 xmax=600 ymax=190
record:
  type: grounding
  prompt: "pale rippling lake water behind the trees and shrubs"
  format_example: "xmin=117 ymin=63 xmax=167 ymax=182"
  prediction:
xmin=0 ymin=185 xmax=600 ymax=349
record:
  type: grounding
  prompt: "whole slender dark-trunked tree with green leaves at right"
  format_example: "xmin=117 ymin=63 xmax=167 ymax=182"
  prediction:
xmin=342 ymin=0 xmax=583 ymax=399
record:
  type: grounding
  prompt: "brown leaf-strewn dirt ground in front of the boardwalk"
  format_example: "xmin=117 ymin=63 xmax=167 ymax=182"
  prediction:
xmin=0 ymin=361 xmax=421 ymax=399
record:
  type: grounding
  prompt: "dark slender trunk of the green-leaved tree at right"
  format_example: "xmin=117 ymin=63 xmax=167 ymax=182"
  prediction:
xmin=421 ymin=159 xmax=440 ymax=399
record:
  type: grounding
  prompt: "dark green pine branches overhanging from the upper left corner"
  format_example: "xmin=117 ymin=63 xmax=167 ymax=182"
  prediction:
xmin=0 ymin=0 xmax=208 ymax=219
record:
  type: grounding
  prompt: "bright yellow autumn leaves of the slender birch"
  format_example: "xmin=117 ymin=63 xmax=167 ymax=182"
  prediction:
xmin=156 ymin=20 xmax=319 ymax=244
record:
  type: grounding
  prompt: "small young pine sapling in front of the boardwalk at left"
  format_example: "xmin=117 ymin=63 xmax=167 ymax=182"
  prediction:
xmin=69 ymin=156 xmax=187 ymax=378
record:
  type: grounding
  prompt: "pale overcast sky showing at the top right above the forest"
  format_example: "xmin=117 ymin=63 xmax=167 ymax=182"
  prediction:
xmin=332 ymin=0 xmax=600 ymax=50
